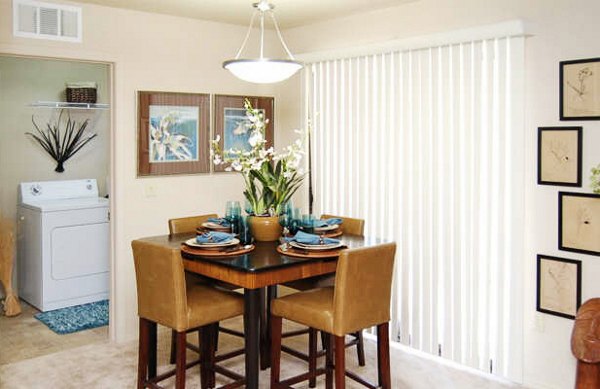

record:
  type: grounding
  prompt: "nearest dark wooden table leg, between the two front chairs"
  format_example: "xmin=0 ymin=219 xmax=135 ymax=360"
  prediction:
xmin=244 ymin=289 xmax=261 ymax=389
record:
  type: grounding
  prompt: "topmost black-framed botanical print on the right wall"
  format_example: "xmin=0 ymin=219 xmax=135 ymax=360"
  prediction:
xmin=560 ymin=58 xmax=600 ymax=120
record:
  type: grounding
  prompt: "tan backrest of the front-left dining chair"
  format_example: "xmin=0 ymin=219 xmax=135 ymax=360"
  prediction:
xmin=131 ymin=240 xmax=188 ymax=331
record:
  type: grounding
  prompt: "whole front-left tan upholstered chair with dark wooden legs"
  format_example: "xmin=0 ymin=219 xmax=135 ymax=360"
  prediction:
xmin=131 ymin=240 xmax=244 ymax=389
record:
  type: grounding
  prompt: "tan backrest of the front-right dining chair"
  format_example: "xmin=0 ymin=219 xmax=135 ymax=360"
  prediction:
xmin=333 ymin=243 xmax=396 ymax=336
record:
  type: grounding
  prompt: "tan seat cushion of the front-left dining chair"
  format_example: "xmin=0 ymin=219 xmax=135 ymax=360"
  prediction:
xmin=187 ymin=284 xmax=244 ymax=329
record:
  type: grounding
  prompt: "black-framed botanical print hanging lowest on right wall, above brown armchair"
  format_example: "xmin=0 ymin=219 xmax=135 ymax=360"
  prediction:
xmin=536 ymin=255 xmax=581 ymax=319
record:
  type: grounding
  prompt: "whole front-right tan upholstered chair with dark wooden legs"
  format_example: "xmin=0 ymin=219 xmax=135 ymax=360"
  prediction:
xmin=271 ymin=243 xmax=396 ymax=389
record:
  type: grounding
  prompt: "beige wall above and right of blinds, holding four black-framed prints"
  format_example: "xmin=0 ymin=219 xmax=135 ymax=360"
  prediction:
xmin=285 ymin=0 xmax=600 ymax=388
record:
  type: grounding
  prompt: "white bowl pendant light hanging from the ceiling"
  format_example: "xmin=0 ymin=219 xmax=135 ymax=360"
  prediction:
xmin=223 ymin=0 xmax=302 ymax=84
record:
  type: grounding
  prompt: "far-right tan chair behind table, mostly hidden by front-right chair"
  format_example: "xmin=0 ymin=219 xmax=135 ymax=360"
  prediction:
xmin=282 ymin=214 xmax=366 ymax=388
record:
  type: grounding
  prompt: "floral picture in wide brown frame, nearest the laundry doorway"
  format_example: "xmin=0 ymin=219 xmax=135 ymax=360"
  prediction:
xmin=138 ymin=91 xmax=210 ymax=176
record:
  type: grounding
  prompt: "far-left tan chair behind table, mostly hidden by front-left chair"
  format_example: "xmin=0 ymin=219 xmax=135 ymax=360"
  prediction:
xmin=169 ymin=214 xmax=244 ymax=363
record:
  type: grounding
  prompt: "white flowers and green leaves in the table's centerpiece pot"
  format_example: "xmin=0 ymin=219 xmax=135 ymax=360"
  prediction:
xmin=210 ymin=99 xmax=304 ymax=216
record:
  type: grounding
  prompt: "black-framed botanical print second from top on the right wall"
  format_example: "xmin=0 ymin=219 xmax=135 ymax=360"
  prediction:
xmin=538 ymin=127 xmax=583 ymax=187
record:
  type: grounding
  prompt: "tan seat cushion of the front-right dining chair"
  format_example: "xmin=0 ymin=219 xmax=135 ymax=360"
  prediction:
xmin=271 ymin=287 xmax=333 ymax=333
